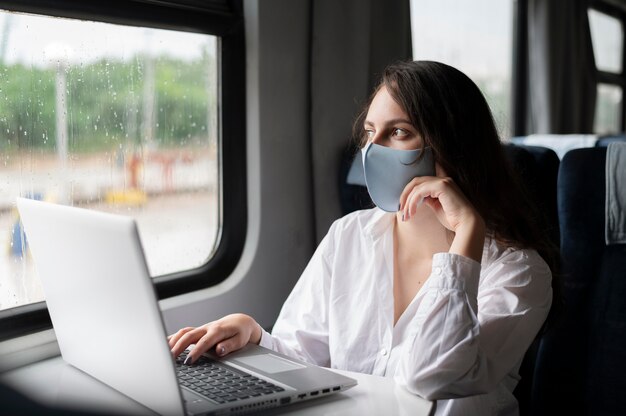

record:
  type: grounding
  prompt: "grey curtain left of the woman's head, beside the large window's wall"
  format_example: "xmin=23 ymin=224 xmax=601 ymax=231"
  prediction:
xmin=311 ymin=0 xmax=412 ymax=241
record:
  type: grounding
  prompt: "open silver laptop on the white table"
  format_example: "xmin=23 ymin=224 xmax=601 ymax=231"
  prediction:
xmin=17 ymin=198 xmax=357 ymax=415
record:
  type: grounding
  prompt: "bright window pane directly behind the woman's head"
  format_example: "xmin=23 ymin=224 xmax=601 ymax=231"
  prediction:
xmin=411 ymin=0 xmax=514 ymax=137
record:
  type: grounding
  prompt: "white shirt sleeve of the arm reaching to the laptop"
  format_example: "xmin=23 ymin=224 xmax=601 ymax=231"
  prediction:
xmin=255 ymin=224 xmax=335 ymax=367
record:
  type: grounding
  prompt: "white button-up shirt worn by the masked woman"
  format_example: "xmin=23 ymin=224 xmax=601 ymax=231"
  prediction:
xmin=261 ymin=208 xmax=552 ymax=415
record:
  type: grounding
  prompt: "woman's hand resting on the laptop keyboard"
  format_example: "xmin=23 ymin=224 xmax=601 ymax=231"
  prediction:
xmin=167 ymin=313 xmax=262 ymax=364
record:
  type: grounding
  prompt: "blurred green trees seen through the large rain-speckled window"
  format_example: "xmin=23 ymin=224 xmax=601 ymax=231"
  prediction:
xmin=0 ymin=51 xmax=217 ymax=154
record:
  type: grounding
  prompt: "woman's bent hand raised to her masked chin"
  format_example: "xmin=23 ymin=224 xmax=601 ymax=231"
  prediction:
xmin=400 ymin=176 xmax=485 ymax=263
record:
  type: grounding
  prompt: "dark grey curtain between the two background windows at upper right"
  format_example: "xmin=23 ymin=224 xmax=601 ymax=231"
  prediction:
xmin=526 ymin=0 xmax=596 ymax=134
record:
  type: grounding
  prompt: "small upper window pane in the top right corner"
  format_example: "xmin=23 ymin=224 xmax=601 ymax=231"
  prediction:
xmin=588 ymin=9 xmax=624 ymax=74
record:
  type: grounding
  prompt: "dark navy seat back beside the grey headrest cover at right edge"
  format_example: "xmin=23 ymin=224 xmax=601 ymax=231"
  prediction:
xmin=532 ymin=147 xmax=626 ymax=415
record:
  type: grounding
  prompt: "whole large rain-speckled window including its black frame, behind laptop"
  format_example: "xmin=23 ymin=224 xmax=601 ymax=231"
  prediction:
xmin=0 ymin=0 xmax=247 ymax=339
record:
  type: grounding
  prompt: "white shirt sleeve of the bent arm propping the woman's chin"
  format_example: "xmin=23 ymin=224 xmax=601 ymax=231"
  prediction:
xmin=395 ymin=250 xmax=552 ymax=400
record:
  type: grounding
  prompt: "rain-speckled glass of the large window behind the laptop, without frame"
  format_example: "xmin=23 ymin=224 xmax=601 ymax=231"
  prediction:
xmin=0 ymin=12 xmax=220 ymax=309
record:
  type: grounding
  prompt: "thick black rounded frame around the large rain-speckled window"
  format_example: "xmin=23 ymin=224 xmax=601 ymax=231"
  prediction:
xmin=0 ymin=0 xmax=247 ymax=341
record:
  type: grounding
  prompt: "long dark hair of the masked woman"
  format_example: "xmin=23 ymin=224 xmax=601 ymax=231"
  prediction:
xmin=354 ymin=61 xmax=561 ymax=328
